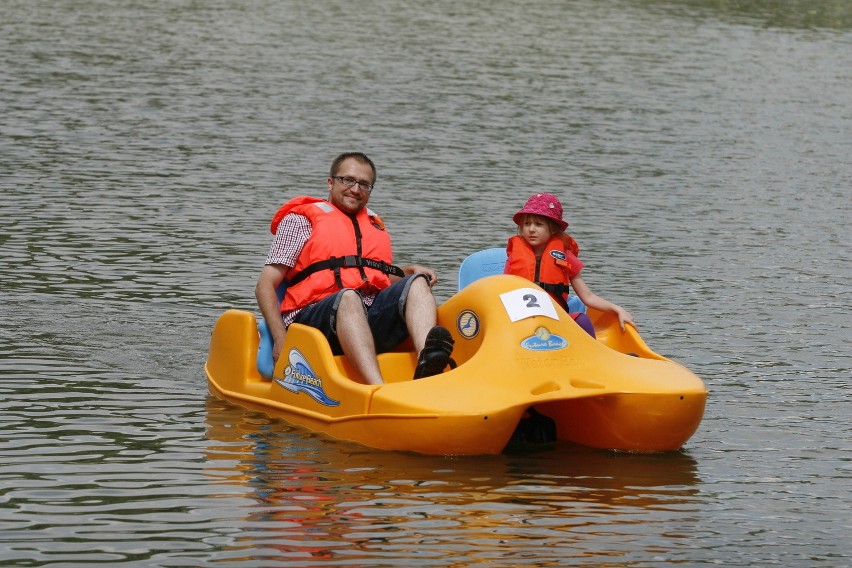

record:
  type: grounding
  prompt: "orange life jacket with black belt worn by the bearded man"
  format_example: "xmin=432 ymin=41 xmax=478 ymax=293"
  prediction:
xmin=270 ymin=196 xmax=404 ymax=312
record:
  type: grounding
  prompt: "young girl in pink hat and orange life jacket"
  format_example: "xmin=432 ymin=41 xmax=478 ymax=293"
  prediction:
xmin=503 ymin=193 xmax=636 ymax=337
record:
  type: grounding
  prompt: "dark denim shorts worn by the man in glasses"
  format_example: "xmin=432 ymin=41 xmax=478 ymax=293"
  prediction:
xmin=293 ymin=274 xmax=426 ymax=355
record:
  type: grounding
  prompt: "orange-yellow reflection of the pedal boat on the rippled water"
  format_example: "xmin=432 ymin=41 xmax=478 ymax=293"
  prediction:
xmin=207 ymin=396 xmax=699 ymax=562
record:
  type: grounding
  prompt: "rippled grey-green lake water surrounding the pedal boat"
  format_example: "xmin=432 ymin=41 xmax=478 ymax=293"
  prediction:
xmin=0 ymin=0 xmax=852 ymax=566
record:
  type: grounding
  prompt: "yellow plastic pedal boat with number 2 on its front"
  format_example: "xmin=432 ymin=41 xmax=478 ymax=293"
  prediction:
xmin=205 ymin=275 xmax=707 ymax=455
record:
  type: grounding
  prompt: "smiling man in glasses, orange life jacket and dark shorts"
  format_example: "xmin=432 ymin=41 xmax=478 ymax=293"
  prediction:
xmin=255 ymin=152 xmax=453 ymax=385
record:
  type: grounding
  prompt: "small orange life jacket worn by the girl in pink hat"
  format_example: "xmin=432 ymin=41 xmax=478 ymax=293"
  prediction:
xmin=510 ymin=233 xmax=583 ymax=309
